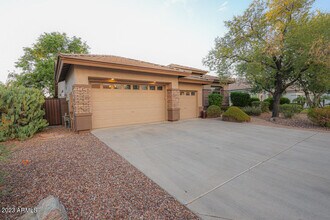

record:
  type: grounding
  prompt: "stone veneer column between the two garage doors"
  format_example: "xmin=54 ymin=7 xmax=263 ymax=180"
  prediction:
xmin=167 ymin=89 xmax=180 ymax=121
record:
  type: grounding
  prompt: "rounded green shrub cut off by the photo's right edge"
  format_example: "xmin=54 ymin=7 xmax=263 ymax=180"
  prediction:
xmin=307 ymin=106 xmax=330 ymax=128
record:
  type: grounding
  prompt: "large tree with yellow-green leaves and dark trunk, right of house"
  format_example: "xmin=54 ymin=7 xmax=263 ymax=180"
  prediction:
xmin=204 ymin=0 xmax=330 ymax=117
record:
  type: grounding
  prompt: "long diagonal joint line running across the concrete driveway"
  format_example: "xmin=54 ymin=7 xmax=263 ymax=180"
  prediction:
xmin=184 ymin=132 xmax=319 ymax=207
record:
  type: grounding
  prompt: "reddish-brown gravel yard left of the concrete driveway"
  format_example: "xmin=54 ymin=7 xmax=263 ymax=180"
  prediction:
xmin=0 ymin=128 xmax=198 ymax=219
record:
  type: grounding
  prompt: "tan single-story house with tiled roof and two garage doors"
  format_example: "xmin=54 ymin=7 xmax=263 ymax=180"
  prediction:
xmin=55 ymin=54 xmax=213 ymax=131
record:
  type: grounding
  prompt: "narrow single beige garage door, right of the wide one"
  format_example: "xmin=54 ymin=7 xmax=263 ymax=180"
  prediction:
xmin=180 ymin=91 xmax=198 ymax=119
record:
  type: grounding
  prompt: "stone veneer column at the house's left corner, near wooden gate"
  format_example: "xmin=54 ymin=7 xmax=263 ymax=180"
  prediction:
xmin=72 ymin=84 xmax=92 ymax=131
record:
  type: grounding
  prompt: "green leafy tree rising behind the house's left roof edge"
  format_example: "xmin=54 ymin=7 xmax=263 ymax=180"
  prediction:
xmin=8 ymin=32 xmax=89 ymax=97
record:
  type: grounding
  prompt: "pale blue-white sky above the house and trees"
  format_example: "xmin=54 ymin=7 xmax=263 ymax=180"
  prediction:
xmin=0 ymin=0 xmax=330 ymax=82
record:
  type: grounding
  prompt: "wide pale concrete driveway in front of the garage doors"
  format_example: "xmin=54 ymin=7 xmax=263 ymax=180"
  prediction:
xmin=93 ymin=119 xmax=330 ymax=220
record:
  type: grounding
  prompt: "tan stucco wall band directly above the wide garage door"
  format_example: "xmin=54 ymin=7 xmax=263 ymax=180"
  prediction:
xmin=74 ymin=66 xmax=178 ymax=89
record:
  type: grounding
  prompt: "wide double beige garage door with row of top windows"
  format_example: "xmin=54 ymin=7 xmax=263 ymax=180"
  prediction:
xmin=91 ymin=84 xmax=166 ymax=129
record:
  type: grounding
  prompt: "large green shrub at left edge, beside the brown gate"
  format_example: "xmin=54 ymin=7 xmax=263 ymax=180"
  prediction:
xmin=0 ymin=87 xmax=48 ymax=141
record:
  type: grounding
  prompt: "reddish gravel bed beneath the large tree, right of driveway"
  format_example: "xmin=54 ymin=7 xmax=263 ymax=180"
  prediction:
xmin=252 ymin=113 xmax=330 ymax=132
